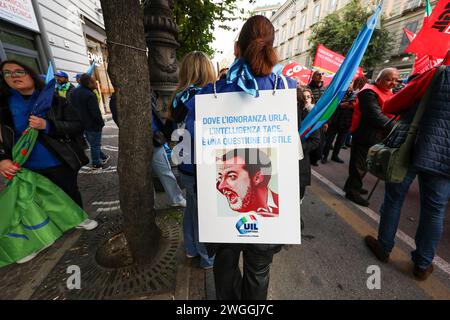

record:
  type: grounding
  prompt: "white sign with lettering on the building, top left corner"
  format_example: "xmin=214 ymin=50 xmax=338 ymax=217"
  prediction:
xmin=0 ymin=0 xmax=40 ymax=32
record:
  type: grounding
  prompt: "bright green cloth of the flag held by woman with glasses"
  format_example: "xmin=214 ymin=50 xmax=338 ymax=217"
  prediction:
xmin=0 ymin=129 xmax=88 ymax=267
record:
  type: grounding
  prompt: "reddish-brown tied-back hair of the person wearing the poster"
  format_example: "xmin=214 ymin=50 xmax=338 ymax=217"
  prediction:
xmin=237 ymin=15 xmax=278 ymax=76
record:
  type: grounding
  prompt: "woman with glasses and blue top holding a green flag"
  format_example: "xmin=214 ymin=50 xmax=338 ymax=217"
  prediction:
xmin=0 ymin=60 xmax=95 ymax=215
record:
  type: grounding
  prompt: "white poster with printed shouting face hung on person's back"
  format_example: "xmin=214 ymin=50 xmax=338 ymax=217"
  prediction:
xmin=195 ymin=89 xmax=301 ymax=244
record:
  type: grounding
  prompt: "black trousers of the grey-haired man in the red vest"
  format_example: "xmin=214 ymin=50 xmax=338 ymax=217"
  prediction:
xmin=344 ymin=143 xmax=369 ymax=195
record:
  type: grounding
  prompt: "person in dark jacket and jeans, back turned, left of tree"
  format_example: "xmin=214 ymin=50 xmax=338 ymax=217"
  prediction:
xmin=70 ymin=73 xmax=110 ymax=169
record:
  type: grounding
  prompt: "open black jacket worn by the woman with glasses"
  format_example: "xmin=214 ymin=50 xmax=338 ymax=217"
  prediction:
xmin=0 ymin=93 xmax=89 ymax=171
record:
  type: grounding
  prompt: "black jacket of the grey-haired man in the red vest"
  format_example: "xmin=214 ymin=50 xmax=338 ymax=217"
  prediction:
xmin=353 ymin=90 xmax=394 ymax=148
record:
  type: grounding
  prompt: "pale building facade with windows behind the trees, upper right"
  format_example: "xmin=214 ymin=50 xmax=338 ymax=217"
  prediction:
xmin=271 ymin=0 xmax=437 ymax=77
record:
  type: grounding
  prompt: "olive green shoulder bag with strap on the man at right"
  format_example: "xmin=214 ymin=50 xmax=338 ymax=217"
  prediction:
xmin=366 ymin=66 xmax=445 ymax=183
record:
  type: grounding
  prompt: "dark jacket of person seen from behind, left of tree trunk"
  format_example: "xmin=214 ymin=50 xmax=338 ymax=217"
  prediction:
xmin=70 ymin=86 xmax=105 ymax=132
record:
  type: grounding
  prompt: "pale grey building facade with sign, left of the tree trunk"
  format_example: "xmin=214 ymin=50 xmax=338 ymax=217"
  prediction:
xmin=0 ymin=0 xmax=113 ymax=113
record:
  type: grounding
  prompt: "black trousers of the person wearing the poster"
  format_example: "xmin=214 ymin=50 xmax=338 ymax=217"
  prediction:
xmin=214 ymin=244 xmax=274 ymax=300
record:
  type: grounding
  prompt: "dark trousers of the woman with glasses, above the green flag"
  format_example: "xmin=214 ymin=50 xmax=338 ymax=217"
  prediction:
xmin=33 ymin=164 xmax=83 ymax=208
